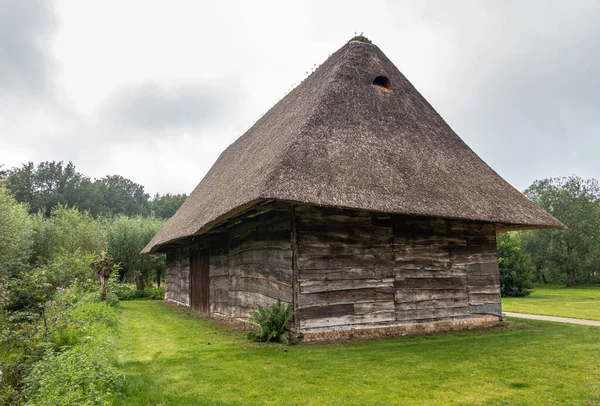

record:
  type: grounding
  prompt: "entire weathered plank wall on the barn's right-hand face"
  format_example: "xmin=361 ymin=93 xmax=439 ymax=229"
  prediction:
xmin=295 ymin=206 xmax=500 ymax=330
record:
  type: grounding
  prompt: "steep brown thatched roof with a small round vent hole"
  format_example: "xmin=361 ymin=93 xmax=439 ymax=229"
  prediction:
xmin=142 ymin=41 xmax=563 ymax=253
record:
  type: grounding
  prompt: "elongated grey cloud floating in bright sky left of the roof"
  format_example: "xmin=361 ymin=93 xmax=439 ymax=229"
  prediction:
xmin=100 ymin=83 xmax=236 ymax=135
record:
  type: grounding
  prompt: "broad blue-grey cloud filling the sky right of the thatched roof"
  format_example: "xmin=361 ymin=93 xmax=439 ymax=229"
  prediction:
xmin=455 ymin=3 xmax=600 ymax=190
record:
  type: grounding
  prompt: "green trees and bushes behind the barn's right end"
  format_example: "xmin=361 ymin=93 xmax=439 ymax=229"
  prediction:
xmin=498 ymin=176 xmax=600 ymax=296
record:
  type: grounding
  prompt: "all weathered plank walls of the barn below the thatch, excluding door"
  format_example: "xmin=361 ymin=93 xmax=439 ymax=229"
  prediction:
xmin=166 ymin=201 xmax=501 ymax=330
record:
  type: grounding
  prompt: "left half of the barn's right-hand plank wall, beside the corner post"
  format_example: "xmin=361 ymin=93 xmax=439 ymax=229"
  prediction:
xmin=295 ymin=206 xmax=396 ymax=329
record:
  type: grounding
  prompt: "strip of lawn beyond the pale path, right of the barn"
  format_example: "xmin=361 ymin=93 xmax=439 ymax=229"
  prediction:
xmin=502 ymin=286 xmax=600 ymax=320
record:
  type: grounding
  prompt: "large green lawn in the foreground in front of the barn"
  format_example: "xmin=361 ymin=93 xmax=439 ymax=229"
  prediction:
xmin=119 ymin=301 xmax=600 ymax=405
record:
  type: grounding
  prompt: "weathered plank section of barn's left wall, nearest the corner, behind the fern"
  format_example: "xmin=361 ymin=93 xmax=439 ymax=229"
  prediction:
xmin=225 ymin=211 xmax=292 ymax=319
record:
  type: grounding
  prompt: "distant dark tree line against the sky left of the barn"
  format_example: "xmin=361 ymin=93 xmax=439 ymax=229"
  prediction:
xmin=0 ymin=161 xmax=187 ymax=218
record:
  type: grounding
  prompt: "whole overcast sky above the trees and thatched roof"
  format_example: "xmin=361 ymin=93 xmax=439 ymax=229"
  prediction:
xmin=0 ymin=0 xmax=600 ymax=193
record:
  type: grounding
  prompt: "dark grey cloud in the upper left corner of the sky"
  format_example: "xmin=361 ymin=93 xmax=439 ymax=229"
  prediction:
xmin=0 ymin=0 xmax=56 ymax=98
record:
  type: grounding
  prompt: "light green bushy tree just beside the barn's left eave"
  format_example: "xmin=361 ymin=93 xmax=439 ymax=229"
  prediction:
xmin=106 ymin=216 xmax=165 ymax=281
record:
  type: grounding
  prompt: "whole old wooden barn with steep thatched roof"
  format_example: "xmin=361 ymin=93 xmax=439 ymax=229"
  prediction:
xmin=143 ymin=40 xmax=563 ymax=339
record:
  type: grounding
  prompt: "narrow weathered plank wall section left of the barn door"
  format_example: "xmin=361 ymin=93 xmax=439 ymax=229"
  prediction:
xmin=165 ymin=245 xmax=190 ymax=306
